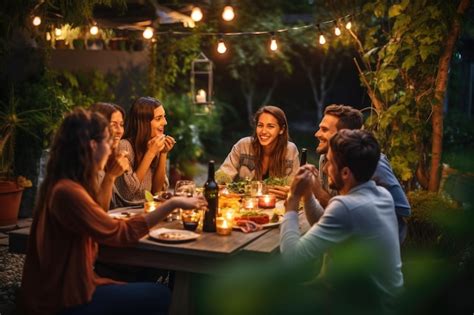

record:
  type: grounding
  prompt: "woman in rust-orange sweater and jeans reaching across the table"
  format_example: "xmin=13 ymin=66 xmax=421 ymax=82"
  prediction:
xmin=19 ymin=109 xmax=206 ymax=314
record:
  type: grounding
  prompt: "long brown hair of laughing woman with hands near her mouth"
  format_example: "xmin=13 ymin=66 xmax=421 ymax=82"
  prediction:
xmin=124 ymin=96 xmax=162 ymax=169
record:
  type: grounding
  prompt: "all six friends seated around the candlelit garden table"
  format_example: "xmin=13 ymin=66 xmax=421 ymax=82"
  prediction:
xmin=21 ymin=97 xmax=410 ymax=314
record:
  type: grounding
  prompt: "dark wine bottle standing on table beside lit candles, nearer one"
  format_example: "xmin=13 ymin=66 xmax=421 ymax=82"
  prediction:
xmin=202 ymin=160 xmax=219 ymax=232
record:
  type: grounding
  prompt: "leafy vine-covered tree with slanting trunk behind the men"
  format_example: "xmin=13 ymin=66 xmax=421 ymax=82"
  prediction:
xmin=344 ymin=0 xmax=470 ymax=191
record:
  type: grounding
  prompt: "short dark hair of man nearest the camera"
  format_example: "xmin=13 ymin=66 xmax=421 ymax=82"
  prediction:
xmin=329 ymin=129 xmax=380 ymax=183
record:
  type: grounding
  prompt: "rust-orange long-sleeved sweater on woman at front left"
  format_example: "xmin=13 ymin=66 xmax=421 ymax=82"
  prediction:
xmin=20 ymin=179 xmax=148 ymax=314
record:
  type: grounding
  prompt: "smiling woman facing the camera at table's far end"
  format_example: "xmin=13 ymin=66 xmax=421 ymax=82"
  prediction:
xmin=219 ymin=105 xmax=299 ymax=196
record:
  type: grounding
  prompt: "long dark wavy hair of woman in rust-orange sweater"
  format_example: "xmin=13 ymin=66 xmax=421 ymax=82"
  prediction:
xmin=35 ymin=108 xmax=109 ymax=216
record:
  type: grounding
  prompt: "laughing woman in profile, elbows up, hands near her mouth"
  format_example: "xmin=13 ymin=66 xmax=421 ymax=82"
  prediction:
xmin=116 ymin=97 xmax=176 ymax=205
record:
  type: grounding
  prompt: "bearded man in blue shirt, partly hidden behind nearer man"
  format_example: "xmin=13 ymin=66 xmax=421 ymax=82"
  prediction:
xmin=313 ymin=105 xmax=411 ymax=243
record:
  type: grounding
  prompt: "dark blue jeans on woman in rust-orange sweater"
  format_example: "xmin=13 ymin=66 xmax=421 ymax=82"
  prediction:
xmin=59 ymin=282 xmax=171 ymax=315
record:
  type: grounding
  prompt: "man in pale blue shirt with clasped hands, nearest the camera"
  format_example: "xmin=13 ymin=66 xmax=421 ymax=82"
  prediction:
xmin=280 ymin=130 xmax=403 ymax=300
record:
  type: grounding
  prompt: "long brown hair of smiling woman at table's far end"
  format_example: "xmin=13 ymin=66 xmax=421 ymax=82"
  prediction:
xmin=252 ymin=105 xmax=289 ymax=180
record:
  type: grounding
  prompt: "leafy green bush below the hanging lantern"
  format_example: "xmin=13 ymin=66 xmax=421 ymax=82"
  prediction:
xmin=163 ymin=94 xmax=221 ymax=175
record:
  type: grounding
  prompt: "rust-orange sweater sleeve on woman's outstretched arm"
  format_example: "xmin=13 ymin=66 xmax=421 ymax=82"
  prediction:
xmin=50 ymin=181 xmax=148 ymax=246
